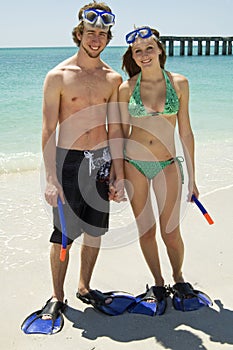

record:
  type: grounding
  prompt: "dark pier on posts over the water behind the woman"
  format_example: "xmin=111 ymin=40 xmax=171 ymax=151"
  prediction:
xmin=160 ymin=36 xmax=233 ymax=56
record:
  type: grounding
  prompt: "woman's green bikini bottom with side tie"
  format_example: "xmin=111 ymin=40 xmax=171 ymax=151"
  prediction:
xmin=125 ymin=155 xmax=184 ymax=184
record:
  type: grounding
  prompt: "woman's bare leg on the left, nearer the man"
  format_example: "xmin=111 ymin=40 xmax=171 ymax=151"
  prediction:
xmin=125 ymin=162 xmax=164 ymax=286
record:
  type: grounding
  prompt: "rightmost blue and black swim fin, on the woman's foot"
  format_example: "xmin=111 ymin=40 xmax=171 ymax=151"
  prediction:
xmin=171 ymin=282 xmax=213 ymax=311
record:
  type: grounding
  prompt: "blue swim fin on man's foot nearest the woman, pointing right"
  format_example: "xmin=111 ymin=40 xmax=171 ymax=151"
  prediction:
xmin=76 ymin=289 xmax=136 ymax=316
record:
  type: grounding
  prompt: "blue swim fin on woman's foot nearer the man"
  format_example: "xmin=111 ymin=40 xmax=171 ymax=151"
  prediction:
xmin=128 ymin=285 xmax=168 ymax=316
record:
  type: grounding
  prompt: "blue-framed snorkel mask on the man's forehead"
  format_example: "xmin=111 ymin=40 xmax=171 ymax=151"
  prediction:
xmin=82 ymin=9 xmax=115 ymax=28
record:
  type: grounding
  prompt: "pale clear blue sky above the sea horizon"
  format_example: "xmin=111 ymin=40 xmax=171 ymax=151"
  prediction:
xmin=0 ymin=0 xmax=233 ymax=47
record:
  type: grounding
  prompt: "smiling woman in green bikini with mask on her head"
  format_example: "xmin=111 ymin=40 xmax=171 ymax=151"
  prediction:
xmin=119 ymin=27 xmax=210 ymax=312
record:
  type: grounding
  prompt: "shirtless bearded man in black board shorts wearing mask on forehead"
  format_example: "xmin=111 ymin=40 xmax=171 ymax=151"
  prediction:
xmin=42 ymin=2 xmax=124 ymax=317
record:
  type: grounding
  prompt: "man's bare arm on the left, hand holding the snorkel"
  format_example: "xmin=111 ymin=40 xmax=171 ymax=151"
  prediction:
xmin=42 ymin=71 xmax=64 ymax=207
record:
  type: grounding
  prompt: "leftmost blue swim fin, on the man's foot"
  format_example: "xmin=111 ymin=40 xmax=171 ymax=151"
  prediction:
xmin=21 ymin=299 xmax=66 ymax=334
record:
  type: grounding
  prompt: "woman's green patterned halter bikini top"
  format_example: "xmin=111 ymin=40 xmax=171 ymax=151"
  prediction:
xmin=128 ymin=69 xmax=179 ymax=118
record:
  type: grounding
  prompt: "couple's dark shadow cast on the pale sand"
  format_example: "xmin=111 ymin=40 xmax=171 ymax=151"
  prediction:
xmin=65 ymin=298 xmax=233 ymax=350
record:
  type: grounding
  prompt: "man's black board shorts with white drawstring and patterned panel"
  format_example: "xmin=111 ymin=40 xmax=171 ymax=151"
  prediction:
xmin=50 ymin=147 xmax=111 ymax=244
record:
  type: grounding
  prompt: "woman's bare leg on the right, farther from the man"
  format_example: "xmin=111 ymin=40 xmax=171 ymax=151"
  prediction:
xmin=153 ymin=163 xmax=184 ymax=282
